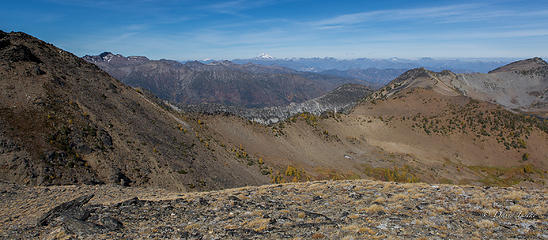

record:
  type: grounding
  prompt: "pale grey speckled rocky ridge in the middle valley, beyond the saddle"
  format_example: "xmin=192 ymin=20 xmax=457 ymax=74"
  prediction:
xmin=179 ymin=84 xmax=372 ymax=125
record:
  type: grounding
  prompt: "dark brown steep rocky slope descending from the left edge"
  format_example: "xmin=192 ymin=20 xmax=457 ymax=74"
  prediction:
xmin=0 ymin=32 xmax=268 ymax=190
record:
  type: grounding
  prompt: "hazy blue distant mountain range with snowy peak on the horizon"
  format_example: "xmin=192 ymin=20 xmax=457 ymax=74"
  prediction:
xmin=228 ymin=54 xmax=517 ymax=73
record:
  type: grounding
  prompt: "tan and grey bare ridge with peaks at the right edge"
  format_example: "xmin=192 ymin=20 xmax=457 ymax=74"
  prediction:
xmin=370 ymin=58 xmax=548 ymax=118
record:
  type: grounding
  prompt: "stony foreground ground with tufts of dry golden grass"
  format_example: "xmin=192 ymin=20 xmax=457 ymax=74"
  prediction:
xmin=0 ymin=180 xmax=548 ymax=239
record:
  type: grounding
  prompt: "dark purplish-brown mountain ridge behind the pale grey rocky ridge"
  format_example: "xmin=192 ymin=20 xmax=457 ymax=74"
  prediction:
xmin=84 ymin=53 xmax=352 ymax=107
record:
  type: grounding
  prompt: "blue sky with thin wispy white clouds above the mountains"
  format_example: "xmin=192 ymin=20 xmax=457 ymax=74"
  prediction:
xmin=0 ymin=0 xmax=548 ymax=60
